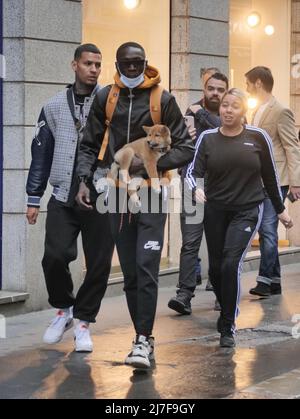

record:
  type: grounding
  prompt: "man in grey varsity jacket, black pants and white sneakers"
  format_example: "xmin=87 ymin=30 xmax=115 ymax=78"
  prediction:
xmin=26 ymin=44 xmax=113 ymax=352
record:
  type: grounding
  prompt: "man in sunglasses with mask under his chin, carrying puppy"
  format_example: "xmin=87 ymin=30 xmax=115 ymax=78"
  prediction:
xmin=77 ymin=42 xmax=194 ymax=368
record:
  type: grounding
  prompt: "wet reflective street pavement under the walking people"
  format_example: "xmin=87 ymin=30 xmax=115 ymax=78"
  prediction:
xmin=0 ymin=264 xmax=300 ymax=399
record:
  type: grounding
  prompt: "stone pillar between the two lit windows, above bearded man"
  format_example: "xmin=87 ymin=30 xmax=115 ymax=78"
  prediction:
xmin=171 ymin=0 xmax=229 ymax=112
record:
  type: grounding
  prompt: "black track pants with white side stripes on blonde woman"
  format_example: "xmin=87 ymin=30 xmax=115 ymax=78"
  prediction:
xmin=204 ymin=203 xmax=263 ymax=332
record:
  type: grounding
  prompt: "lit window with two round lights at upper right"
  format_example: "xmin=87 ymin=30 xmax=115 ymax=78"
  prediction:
xmin=230 ymin=0 xmax=291 ymax=106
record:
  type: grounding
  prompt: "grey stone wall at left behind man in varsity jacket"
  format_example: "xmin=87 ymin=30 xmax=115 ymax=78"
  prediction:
xmin=3 ymin=0 xmax=83 ymax=310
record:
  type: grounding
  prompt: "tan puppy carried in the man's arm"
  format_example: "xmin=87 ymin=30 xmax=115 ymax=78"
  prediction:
xmin=108 ymin=124 xmax=171 ymax=206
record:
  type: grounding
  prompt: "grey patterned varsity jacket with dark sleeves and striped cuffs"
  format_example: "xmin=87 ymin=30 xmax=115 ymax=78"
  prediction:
xmin=26 ymin=85 xmax=100 ymax=207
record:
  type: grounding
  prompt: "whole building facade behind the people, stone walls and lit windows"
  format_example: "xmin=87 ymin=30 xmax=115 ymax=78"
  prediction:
xmin=0 ymin=0 xmax=300 ymax=311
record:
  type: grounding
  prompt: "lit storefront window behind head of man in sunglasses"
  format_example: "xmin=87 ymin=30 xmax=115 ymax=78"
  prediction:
xmin=82 ymin=0 xmax=170 ymax=272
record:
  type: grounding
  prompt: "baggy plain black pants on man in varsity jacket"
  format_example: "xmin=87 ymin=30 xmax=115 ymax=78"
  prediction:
xmin=42 ymin=197 xmax=114 ymax=323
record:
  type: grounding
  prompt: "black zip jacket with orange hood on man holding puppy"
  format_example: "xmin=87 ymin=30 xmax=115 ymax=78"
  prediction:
xmin=77 ymin=66 xmax=194 ymax=178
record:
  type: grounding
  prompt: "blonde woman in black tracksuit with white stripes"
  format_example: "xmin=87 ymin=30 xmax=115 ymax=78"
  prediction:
xmin=187 ymin=89 xmax=293 ymax=347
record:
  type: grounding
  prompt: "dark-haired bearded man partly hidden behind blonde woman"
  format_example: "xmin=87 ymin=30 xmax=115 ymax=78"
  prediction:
xmin=168 ymin=73 xmax=228 ymax=314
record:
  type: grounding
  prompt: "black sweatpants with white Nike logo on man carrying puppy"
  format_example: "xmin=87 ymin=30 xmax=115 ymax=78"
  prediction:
xmin=110 ymin=194 xmax=167 ymax=336
